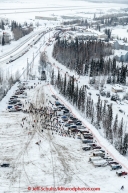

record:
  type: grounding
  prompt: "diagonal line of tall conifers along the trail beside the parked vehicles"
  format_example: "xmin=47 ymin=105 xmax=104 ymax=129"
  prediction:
xmin=51 ymin=70 xmax=128 ymax=155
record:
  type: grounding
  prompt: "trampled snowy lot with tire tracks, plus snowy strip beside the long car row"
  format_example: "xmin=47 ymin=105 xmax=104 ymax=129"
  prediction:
xmin=0 ymin=80 xmax=128 ymax=193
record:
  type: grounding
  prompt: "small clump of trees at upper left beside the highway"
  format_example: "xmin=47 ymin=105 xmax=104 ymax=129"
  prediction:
xmin=11 ymin=21 xmax=33 ymax=40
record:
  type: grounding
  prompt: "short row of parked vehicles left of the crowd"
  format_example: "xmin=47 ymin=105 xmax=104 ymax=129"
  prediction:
xmin=7 ymin=83 xmax=27 ymax=112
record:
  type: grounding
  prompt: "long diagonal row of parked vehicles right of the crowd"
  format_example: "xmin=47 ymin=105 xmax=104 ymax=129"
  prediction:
xmin=53 ymin=98 xmax=127 ymax=176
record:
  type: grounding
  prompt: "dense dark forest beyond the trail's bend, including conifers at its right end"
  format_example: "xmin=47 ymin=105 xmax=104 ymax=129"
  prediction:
xmin=52 ymin=39 xmax=128 ymax=85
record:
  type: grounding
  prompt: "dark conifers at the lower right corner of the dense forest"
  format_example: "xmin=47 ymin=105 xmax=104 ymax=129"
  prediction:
xmin=88 ymin=58 xmax=128 ymax=85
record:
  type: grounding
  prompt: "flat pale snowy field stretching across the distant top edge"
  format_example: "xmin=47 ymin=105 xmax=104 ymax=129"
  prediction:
xmin=0 ymin=0 xmax=128 ymax=22
